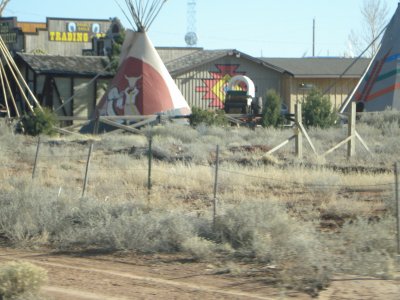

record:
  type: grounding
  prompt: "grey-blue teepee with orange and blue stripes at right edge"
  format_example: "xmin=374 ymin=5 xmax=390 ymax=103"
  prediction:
xmin=353 ymin=4 xmax=400 ymax=111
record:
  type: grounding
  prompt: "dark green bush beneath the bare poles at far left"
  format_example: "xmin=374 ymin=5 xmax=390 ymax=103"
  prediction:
xmin=21 ymin=107 xmax=57 ymax=136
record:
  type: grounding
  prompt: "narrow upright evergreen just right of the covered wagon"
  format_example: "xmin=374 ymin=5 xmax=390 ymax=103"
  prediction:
xmin=261 ymin=90 xmax=284 ymax=128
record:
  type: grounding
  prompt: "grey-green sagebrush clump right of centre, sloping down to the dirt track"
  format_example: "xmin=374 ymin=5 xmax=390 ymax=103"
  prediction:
xmin=211 ymin=201 xmax=330 ymax=290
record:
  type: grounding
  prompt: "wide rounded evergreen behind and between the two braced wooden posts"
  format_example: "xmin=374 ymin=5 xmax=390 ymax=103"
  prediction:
xmin=302 ymin=89 xmax=337 ymax=128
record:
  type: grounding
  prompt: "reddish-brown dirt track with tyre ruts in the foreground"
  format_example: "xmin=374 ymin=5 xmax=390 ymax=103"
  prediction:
xmin=0 ymin=248 xmax=400 ymax=300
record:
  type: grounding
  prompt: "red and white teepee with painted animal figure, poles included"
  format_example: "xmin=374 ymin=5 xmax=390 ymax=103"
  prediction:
xmin=97 ymin=0 xmax=191 ymax=116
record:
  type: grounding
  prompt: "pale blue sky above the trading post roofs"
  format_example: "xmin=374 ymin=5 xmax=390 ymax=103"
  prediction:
xmin=3 ymin=0 xmax=398 ymax=57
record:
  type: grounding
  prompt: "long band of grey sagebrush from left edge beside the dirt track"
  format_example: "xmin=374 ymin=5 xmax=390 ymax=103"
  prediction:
xmin=0 ymin=182 xmax=194 ymax=252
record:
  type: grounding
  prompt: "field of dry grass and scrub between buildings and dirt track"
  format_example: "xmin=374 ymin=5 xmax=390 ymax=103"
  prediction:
xmin=0 ymin=113 xmax=399 ymax=293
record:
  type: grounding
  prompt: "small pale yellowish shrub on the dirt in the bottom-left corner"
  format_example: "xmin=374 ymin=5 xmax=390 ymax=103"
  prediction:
xmin=0 ymin=262 xmax=47 ymax=300
